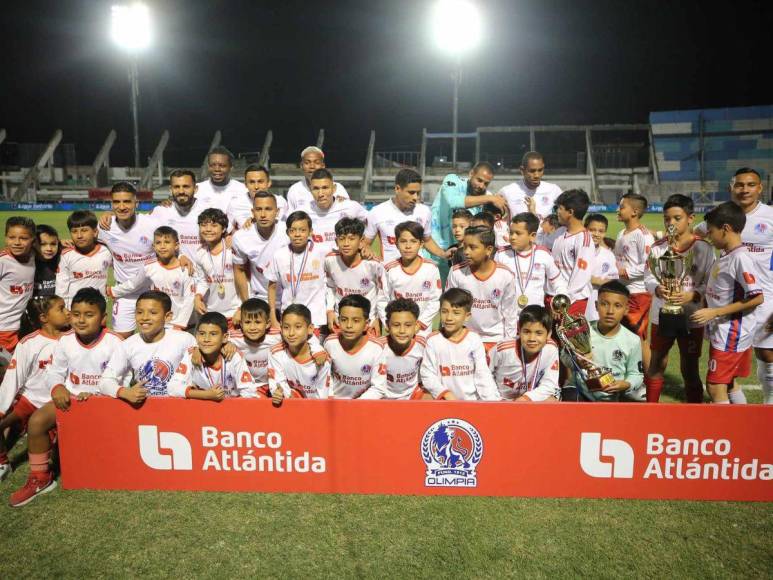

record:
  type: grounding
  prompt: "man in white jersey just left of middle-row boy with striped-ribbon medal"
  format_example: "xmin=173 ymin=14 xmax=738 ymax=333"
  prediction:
xmin=231 ymin=191 xmax=290 ymax=301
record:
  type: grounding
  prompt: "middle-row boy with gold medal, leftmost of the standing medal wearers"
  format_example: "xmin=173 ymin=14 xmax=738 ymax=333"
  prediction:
xmin=194 ymin=208 xmax=241 ymax=321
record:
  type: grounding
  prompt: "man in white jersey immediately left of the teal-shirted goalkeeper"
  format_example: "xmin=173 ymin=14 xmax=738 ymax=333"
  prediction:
xmin=364 ymin=169 xmax=447 ymax=264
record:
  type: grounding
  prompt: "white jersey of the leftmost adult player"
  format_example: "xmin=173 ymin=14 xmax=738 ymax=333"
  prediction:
xmin=98 ymin=214 xmax=164 ymax=286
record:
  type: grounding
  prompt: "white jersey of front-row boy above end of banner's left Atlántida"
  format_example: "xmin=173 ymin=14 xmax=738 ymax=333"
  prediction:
xmin=268 ymin=343 xmax=330 ymax=399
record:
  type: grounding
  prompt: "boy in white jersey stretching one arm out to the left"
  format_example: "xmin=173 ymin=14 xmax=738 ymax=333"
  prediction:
xmin=108 ymin=226 xmax=196 ymax=330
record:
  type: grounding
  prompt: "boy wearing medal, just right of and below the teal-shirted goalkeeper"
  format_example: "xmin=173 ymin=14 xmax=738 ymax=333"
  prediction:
xmin=495 ymin=212 xmax=566 ymax=313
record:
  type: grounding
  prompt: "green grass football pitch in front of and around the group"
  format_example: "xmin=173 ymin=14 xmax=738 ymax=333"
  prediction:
xmin=0 ymin=212 xmax=773 ymax=578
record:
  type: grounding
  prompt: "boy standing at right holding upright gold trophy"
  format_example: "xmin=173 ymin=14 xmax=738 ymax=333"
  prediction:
xmin=644 ymin=193 xmax=714 ymax=403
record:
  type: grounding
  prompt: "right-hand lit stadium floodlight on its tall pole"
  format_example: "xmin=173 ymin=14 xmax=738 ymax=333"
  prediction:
xmin=432 ymin=0 xmax=481 ymax=167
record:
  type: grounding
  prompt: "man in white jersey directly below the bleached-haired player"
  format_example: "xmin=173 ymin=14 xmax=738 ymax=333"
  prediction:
xmin=305 ymin=169 xmax=368 ymax=253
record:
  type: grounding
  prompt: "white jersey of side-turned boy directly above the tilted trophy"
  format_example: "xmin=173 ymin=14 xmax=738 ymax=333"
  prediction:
xmin=553 ymin=229 xmax=596 ymax=302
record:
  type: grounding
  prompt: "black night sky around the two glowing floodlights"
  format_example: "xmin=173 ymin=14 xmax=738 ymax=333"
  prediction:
xmin=0 ymin=0 xmax=773 ymax=166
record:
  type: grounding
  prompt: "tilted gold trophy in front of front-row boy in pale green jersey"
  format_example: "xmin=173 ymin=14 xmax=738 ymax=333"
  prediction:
xmin=551 ymin=294 xmax=615 ymax=391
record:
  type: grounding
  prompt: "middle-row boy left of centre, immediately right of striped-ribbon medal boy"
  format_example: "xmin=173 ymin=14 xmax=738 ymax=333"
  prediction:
xmin=325 ymin=218 xmax=384 ymax=336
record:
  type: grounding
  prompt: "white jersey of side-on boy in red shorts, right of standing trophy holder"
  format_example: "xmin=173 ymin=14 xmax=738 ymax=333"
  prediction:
xmin=706 ymin=246 xmax=762 ymax=352
